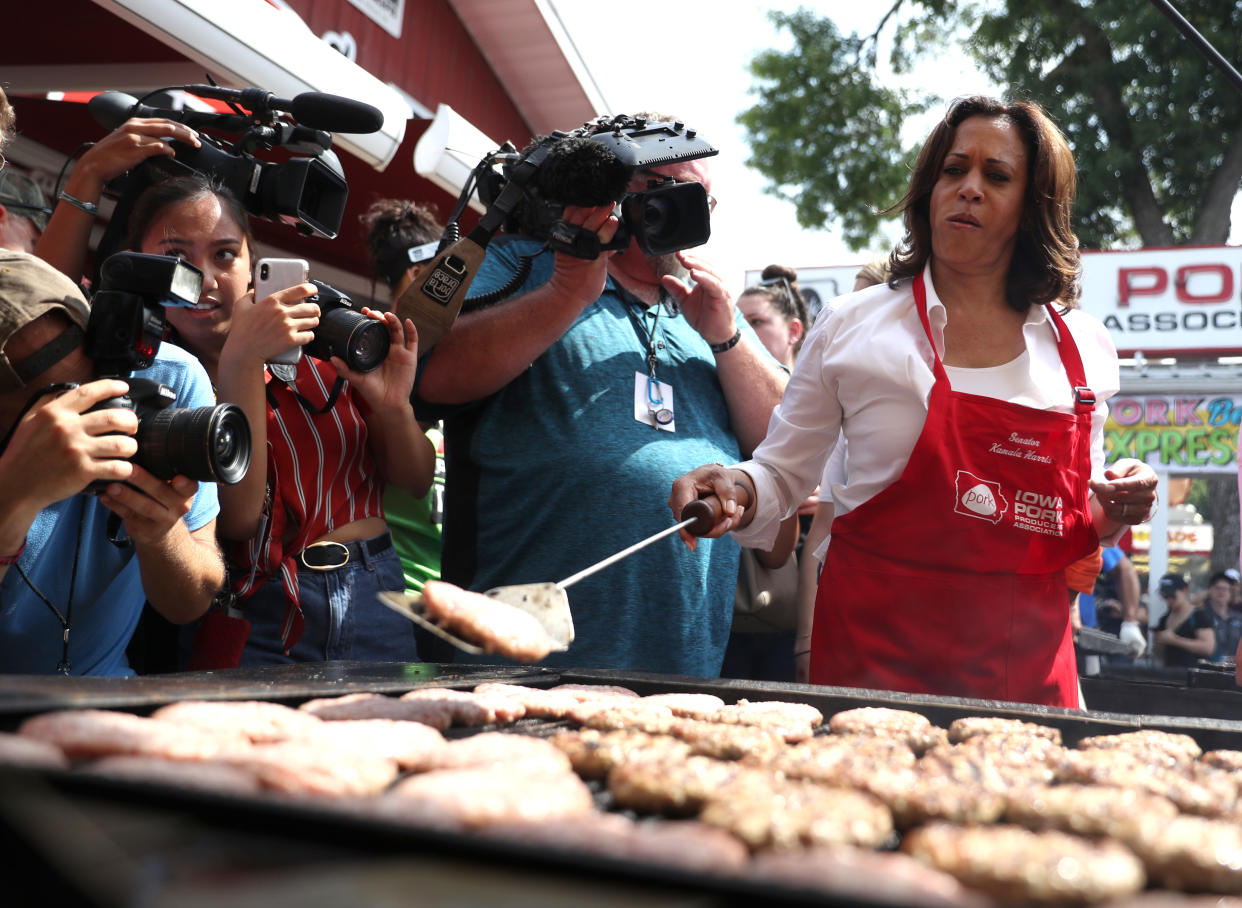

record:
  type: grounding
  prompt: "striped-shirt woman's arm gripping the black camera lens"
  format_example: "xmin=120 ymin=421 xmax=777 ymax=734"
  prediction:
xmin=332 ymin=308 xmax=436 ymax=498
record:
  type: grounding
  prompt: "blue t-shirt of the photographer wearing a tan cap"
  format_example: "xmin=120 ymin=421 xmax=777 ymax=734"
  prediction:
xmin=0 ymin=343 xmax=220 ymax=674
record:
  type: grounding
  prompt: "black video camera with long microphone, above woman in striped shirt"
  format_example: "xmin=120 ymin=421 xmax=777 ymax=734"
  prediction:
xmin=87 ymin=84 xmax=384 ymax=268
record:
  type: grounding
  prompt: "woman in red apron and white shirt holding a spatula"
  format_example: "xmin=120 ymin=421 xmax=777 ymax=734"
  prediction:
xmin=669 ymin=97 xmax=1156 ymax=707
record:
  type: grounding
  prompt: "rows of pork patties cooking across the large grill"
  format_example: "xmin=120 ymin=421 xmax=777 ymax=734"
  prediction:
xmin=0 ymin=683 xmax=1242 ymax=904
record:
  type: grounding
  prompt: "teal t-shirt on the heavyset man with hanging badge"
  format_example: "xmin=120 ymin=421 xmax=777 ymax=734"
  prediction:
xmin=443 ymin=237 xmax=758 ymax=677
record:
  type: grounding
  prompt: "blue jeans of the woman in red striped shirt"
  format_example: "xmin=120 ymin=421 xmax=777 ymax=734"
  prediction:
xmin=241 ymin=536 xmax=419 ymax=666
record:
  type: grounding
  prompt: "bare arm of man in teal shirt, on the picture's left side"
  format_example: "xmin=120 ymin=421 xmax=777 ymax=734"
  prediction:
xmin=419 ymin=205 xmax=619 ymax=404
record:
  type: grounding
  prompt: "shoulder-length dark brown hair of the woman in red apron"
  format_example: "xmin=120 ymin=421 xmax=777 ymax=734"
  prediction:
xmin=889 ymin=96 xmax=1082 ymax=312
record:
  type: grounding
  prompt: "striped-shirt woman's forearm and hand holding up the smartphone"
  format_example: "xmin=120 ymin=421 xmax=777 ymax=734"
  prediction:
xmin=216 ymin=283 xmax=319 ymax=539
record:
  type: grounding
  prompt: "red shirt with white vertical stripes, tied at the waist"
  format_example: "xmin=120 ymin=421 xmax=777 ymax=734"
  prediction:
xmin=230 ymin=356 xmax=385 ymax=650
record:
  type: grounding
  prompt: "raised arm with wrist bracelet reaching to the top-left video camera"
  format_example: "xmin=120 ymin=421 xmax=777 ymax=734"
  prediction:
xmin=35 ymin=118 xmax=202 ymax=281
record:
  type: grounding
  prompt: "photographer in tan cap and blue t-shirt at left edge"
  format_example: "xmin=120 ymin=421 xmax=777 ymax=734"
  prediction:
xmin=0 ymin=252 xmax=224 ymax=674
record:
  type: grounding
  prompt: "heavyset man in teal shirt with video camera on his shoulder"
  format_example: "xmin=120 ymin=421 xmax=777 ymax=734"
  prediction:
xmin=417 ymin=127 xmax=785 ymax=677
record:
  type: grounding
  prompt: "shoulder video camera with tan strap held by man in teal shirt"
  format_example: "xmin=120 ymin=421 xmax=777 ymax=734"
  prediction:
xmin=396 ymin=114 xmax=718 ymax=349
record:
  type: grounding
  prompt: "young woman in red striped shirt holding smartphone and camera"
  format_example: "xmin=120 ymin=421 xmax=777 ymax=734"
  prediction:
xmin=128 ymin=174 xmax=435 ymax=668
